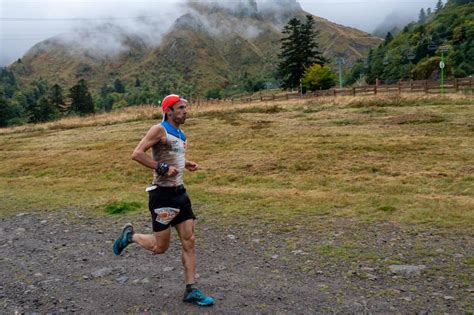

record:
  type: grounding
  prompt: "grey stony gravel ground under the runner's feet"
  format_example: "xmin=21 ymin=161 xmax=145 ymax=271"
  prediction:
xmin=0 ymin=209 xmax=474 ymax=314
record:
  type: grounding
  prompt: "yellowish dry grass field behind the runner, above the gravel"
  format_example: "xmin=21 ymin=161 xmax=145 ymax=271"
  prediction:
xmin=0 ymin=96 xmax=474 ymax=231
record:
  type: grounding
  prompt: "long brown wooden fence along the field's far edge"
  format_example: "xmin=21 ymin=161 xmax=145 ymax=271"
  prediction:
xmin=193 ymin=77 xmax=474 ymax=105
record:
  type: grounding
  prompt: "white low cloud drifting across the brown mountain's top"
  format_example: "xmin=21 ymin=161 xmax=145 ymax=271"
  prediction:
xmin=25 ymin=0 xmax=301 ymax=59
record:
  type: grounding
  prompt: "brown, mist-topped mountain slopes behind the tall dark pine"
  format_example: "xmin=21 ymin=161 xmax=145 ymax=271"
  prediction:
xmin=10 ymin=0 xmax=381 ymax=95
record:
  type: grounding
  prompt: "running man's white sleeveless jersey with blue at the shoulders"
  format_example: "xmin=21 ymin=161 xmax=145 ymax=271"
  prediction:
xmin=151 ymin=121 xmax=186 ymax=187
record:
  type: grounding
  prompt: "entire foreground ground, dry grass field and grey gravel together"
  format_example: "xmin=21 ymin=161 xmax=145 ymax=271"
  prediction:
xmin=0 ymin=95 xmax=474 ymax=314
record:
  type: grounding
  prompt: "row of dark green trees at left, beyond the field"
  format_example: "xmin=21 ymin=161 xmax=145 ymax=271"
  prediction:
xmin=0 ymin=68 xmax=164 ymax=127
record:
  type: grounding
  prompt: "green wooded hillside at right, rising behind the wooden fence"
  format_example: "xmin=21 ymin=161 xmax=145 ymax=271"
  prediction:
xmin=352 ymin=0 xmax=474 ymax=83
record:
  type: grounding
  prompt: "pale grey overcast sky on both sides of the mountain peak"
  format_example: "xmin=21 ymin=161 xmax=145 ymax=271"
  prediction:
xmin=0 ymin=0 xmax=437 ymax=66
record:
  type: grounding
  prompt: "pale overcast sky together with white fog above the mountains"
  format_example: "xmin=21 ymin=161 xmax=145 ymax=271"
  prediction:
xmin=0 ymin=0 xmax=436 ymax=65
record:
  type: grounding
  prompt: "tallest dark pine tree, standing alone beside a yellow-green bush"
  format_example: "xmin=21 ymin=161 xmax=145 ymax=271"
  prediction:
xmin=278 ymin=15 xmax=326 ymax=89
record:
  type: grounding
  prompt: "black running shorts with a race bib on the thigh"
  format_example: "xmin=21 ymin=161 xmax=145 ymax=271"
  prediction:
xmin=148 ymin=186 xmax=196 ymax=232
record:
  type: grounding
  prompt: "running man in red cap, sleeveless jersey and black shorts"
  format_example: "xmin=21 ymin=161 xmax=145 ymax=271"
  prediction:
xmin=113 ymin=94 xmax=214 ymax=306
